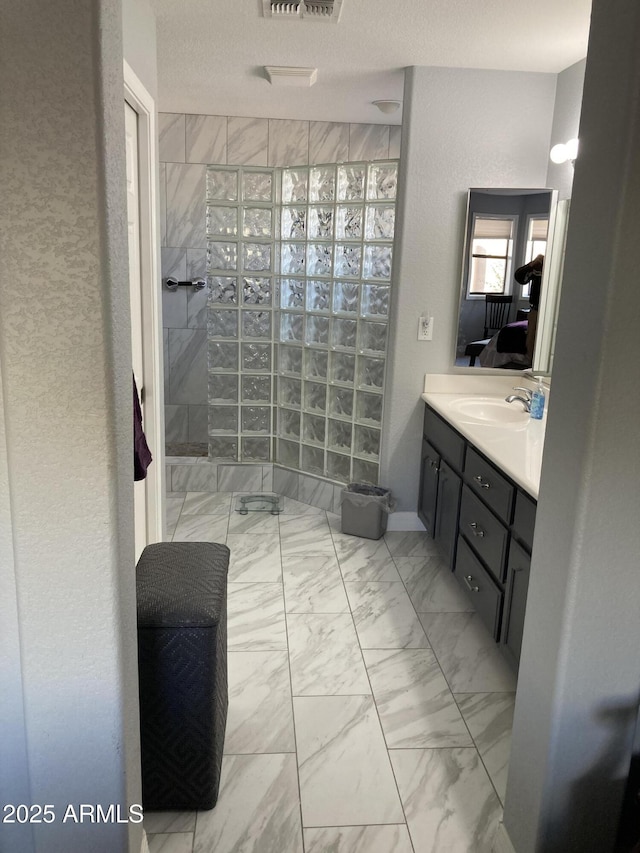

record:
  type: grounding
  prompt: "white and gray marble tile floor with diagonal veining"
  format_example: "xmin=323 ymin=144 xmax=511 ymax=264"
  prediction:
xmin=145 ymin=492 xmax=515 ymax=853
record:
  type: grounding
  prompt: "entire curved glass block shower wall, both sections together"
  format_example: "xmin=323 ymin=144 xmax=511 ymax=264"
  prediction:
xmin=207 ymin=161 xmax=397 ymax=483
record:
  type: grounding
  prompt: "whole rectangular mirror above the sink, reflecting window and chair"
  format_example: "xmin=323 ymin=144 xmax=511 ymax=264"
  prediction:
xmin=454 ymin=188 xmax=568 ymax=374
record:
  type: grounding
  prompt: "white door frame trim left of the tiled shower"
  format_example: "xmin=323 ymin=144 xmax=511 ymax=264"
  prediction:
xmin=123 ymin=59 xmax=165 ymax=543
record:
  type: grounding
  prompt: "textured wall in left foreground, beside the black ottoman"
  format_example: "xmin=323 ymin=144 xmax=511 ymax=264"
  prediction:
xmin=0 ymin=0 xmax=153 ymax=853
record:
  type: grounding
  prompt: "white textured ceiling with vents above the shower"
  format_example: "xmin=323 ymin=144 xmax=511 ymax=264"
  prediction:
xmin=151 ymin=0 xmax=591 ymax=124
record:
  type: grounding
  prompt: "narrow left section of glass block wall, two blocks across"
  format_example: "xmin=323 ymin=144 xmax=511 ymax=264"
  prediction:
xmin=207 ymin=166 xmax=276 ymax=462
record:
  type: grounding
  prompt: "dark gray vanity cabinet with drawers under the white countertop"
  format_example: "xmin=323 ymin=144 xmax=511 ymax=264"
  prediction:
xmin=418 ymin=405 xmax=536 ymax=669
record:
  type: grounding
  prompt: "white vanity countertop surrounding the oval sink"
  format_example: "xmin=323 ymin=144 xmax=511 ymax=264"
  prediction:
xmin=421 ymin=374 xmax=549 ymax=500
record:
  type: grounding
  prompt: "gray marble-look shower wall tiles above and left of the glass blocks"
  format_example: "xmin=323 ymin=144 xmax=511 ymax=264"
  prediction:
xmin=159 ymin=118 xmax=400 ymax=456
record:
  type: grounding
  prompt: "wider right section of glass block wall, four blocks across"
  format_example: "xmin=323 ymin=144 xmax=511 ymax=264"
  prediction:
xmin=275 ymin=161 xmax=397 ymax=483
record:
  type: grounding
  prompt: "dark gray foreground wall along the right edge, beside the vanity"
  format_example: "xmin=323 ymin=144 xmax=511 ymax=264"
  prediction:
xmin=504 ymin=0 xmax=640 ymax=853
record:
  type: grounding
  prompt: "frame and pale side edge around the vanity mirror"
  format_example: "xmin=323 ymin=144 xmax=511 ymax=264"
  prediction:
xmin=453 ymin=187 xmax=569 ymax=376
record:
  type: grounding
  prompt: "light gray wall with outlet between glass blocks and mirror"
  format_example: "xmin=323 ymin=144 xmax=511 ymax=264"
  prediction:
xmin=381 ymin=67 xmax=556 ymax=512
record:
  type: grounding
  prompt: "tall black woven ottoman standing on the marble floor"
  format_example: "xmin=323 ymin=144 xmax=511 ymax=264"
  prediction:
xmin=136 ymin=542 xmax=229 ymax=811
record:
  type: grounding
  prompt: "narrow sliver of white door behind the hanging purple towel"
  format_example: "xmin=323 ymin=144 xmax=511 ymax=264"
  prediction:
xmin=124 ymin=101 xmax=148 ymax=562
